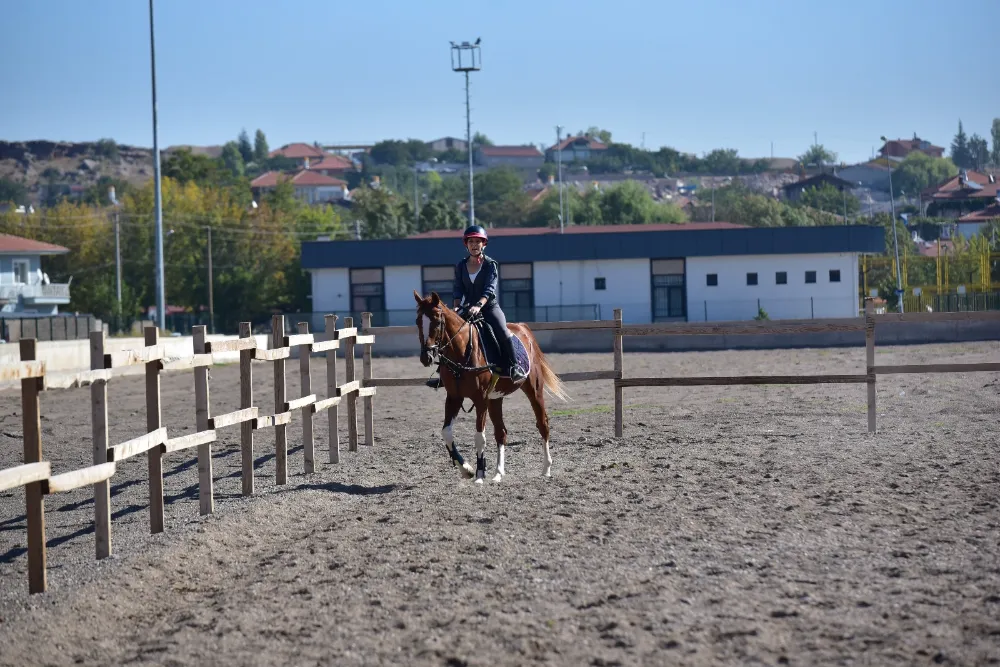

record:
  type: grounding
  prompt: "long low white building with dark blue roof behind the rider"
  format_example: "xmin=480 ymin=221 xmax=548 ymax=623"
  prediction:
xmin=302 ymin=222 xmax=885 ymax=325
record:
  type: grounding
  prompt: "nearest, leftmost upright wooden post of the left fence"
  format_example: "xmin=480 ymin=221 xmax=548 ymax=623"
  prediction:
xmin=20 ymin=338 xmax=47 ymax=593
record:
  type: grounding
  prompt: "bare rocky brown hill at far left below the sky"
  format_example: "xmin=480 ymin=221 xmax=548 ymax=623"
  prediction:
xmin=0 ymin=139 xmax=156 ymax=204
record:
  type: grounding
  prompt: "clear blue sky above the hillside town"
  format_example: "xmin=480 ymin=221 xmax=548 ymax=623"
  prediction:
xmin=0 ymin=0 xmax=1000 ymax=161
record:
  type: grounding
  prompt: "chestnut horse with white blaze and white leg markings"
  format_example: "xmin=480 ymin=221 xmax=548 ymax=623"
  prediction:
xmin=413 ymin=290 xmax=568 ymax=484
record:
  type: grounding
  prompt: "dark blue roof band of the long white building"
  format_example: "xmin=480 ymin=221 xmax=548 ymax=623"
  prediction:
xmin=302 ymin=223 xmax=885 ymax=269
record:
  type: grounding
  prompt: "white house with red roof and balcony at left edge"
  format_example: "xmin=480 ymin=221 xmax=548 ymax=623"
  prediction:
xmin=0 ymin=234 xmax=69 ymax=315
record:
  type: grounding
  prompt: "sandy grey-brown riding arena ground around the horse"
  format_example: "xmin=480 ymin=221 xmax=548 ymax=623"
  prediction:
xmin=0 ymin=343 xmax=1000 ymax=665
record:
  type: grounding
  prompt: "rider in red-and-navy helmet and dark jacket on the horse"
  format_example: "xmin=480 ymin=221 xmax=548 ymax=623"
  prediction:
xmin=427 ymin=225 xmax=526 ymax=389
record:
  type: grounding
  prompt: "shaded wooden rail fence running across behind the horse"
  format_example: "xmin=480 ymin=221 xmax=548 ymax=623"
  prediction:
xmin=362 ymin=297 xmax=1000 ymax=437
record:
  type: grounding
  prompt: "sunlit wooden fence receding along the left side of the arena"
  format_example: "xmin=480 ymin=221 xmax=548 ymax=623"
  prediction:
xmin=0 ymin=314 xmax=376 ymax=593
